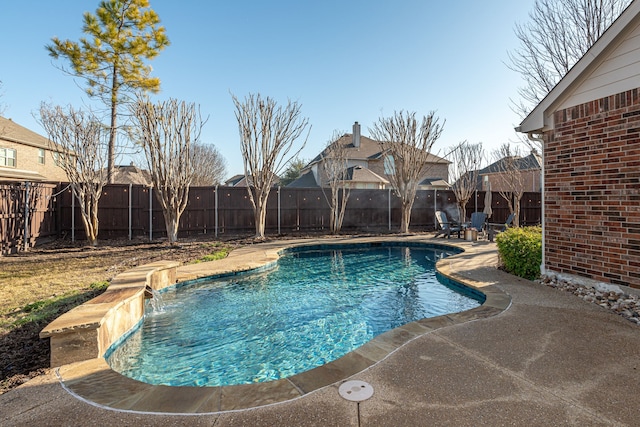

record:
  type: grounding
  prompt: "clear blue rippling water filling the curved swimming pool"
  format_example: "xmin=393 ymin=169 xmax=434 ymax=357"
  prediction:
xmin=107 ymin=246 xmax=480 ymax=386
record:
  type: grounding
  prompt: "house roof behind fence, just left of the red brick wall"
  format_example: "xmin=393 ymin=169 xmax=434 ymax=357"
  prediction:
xmin=478 ymin=152 xmax=542 ymax=193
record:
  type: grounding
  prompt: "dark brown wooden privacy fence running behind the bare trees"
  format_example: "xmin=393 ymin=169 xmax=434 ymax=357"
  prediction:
xmin=0 ymin=183 xmax=541 ymax=253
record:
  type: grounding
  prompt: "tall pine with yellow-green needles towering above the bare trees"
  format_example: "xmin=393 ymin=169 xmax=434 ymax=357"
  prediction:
xmin=46 ymin=0 xmax=169 ymax=182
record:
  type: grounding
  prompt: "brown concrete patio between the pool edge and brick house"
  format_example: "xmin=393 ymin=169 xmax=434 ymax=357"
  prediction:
xmin=0 ymin=236 xmax=640 ymax=427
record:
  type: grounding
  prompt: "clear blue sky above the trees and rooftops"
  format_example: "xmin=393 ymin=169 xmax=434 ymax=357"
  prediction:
xmin=0 ymin=0 xmax=534 ymax=176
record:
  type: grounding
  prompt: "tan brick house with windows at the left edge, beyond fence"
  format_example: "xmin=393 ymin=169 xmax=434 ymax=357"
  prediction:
xmin=0 ymin=117 xmax=67 ymax=182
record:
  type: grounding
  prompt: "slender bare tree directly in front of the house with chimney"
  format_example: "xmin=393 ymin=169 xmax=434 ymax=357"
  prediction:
xmin=322 ymin=131 xmax=351 ymax=234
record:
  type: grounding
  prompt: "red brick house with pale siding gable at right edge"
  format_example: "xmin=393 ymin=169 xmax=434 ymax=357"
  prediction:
xmin=516 ymin=1 xmax=640 ymax=288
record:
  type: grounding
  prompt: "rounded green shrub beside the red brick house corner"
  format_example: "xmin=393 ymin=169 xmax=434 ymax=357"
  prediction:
xmin=496 ymin=227 xmax=542 ymax=280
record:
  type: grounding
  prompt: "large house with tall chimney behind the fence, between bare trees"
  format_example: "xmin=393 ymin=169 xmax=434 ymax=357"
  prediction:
xmin=287 ymin=122 xmax=450 ymax=190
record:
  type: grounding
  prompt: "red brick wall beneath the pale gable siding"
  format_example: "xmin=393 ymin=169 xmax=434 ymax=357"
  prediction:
xmin=545 ymin=89 xmax=640 ymax=288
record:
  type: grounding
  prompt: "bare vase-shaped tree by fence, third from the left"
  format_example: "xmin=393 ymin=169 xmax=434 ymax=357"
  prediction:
xmin=231 ymin=94 xmax=309 ymax=239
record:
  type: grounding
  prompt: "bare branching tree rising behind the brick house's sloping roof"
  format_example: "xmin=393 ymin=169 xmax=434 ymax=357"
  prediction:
xmin=509 ymin=0 xmax=631 ymax=117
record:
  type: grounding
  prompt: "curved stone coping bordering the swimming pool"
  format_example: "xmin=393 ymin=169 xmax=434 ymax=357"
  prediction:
xmin=48 ymin=235 xmax=511 ymax=414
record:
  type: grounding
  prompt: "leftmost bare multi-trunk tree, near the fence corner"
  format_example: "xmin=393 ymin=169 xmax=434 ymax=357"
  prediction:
xmin=40 ymin=103 xmax=108 ymax=246
